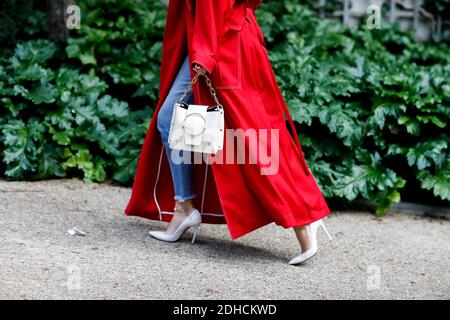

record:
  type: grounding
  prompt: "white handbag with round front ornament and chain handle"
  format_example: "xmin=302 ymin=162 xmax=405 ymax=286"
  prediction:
xmin=169 ymin=73 xmax=225 ymax=154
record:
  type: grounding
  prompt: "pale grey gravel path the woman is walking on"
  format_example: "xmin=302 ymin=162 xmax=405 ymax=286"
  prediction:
xmin=0 ymin=179 xmax=450 ymax=299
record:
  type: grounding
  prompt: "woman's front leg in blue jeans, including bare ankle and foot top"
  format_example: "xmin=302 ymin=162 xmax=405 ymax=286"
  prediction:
xmin=157 ymin=56 xmax=196 ymax=233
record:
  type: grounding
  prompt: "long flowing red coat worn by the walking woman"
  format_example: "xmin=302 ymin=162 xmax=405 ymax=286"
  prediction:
xmin=125 ymin=0 xmax=330 ymax=239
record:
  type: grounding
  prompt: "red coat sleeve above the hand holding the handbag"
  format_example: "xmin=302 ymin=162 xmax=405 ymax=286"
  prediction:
xmin=191 ymin=0 xmax=234 ymax=74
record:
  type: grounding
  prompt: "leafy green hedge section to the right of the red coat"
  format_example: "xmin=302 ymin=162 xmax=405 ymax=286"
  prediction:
xmin=259 ymin=1 xmax=450 ymax=212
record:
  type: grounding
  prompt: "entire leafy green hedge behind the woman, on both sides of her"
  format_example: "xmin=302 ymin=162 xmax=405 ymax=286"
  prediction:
xmin=0 ymin=0 xmax=450 ymax=213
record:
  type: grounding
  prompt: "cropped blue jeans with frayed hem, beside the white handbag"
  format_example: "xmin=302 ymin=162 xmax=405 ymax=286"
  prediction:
xmin=157 ymin=56 xmax=196 ymax=201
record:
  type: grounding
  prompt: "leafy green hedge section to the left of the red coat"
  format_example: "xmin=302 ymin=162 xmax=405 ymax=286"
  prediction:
xmin=0 ymin=0 xmax=166 ymax=183
